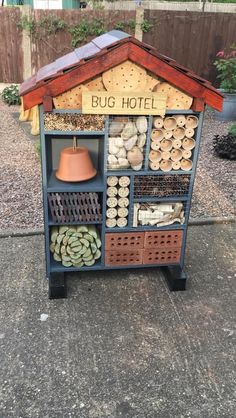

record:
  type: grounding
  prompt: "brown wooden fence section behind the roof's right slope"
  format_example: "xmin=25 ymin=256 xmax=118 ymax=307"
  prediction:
xmin=143 ymin=10 xmax=236 ymax=83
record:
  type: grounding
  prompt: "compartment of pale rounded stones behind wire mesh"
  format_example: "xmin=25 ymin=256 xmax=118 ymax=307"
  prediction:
xmin=107 ymin=116 xmax=149 ymax=171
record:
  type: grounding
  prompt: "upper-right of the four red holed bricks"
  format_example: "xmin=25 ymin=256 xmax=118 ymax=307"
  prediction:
xmin=144 ymin=230 xmax=183 ymax=249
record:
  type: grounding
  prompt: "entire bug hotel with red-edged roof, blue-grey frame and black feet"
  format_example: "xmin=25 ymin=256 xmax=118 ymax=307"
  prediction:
xmin=20 ymin=30 xmax=223 ymax=298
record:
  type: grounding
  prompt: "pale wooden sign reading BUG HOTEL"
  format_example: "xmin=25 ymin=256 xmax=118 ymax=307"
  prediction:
xmin=82 ymin=91 xmax=167 ymax=116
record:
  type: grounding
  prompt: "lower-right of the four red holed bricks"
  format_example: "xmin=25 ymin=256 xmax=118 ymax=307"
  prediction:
xmin=143 ymin=248 xmax=181 ymax=264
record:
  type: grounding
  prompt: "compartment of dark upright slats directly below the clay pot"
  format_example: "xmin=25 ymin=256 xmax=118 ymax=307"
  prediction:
xmin=48 ymin=192 xmax=102 ymax=224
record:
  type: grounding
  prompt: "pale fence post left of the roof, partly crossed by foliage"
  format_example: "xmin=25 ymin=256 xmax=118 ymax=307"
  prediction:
xmin=20 ymin=6 xmax=32 ymax=80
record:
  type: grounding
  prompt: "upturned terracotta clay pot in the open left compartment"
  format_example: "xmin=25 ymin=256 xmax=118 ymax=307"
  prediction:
xmin=56 ymin=147 xmax=97 ymax=182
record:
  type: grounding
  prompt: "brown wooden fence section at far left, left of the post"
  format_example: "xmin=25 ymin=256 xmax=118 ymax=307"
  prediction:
xmin=0 ymin=7 xmax=23 ymax=83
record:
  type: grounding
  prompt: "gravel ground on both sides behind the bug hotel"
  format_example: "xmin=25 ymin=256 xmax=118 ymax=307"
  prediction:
xmin=0 ymin=101 xmax=236 ymax=231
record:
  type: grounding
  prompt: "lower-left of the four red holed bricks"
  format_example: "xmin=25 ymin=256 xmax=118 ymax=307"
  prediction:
xmin=105 ymin=250 xmax=143 ymax=266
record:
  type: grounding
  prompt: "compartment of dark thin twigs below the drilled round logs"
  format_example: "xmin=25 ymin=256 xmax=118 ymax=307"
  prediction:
xmin=134 ymin=174 xmax=191 ymax=198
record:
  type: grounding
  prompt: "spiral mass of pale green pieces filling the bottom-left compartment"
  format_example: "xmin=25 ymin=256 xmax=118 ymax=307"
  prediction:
xmin=50 ymin=225 xmax=102 ymax=267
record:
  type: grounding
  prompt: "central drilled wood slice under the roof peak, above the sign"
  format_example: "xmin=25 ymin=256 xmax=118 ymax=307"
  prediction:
xmin=102 ymin=61 xmax=147 ymax=91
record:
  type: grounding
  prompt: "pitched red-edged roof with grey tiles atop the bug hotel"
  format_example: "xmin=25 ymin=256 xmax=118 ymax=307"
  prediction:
xmin=20 ymin=30 xmax=223 ymax=110
